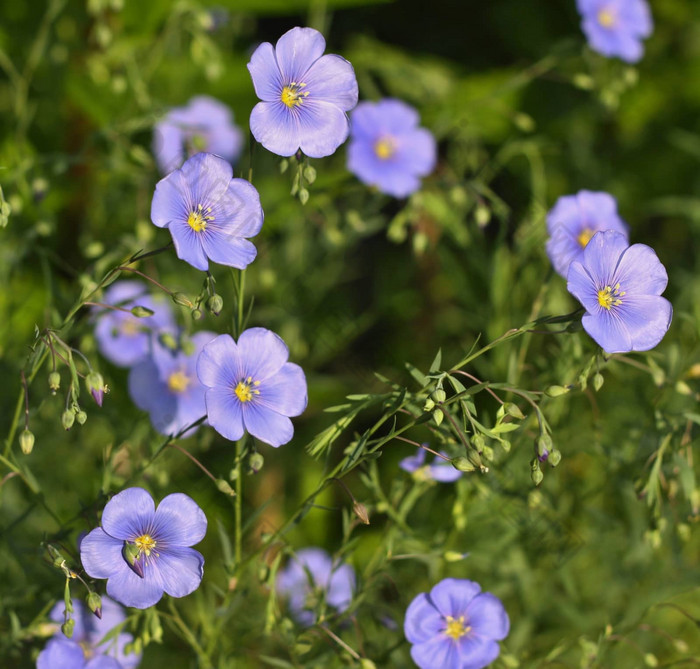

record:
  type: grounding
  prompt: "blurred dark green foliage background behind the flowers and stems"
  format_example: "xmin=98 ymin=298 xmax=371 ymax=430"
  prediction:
xmin=0 ymin=0 xmax=700 ymax=668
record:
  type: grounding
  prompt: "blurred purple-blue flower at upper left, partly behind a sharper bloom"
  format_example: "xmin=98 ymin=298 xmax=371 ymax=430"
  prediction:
xmin=153 ymin=95 xmax=243 ymax=174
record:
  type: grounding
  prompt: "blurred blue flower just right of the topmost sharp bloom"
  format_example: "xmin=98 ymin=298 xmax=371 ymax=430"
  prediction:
xmin=348 ymin=99 xmax=437 ymax=197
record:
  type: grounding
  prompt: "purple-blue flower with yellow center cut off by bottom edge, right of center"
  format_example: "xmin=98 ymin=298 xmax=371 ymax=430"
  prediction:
xmin=404 ymin=578 xmax=510 ymax=669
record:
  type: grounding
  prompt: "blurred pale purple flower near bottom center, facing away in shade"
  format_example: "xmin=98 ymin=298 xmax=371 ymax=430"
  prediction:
xmin=276 ymin=548 xmax=355 ymax=625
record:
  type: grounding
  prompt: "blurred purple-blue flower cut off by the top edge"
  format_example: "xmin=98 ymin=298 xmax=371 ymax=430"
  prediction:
xmin=576 ymin=0 xmax=654 ymax=63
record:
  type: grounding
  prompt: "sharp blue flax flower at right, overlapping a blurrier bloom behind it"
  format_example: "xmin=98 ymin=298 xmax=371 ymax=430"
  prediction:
xmin=567 ymin=230 xmax=673 ymax=353
